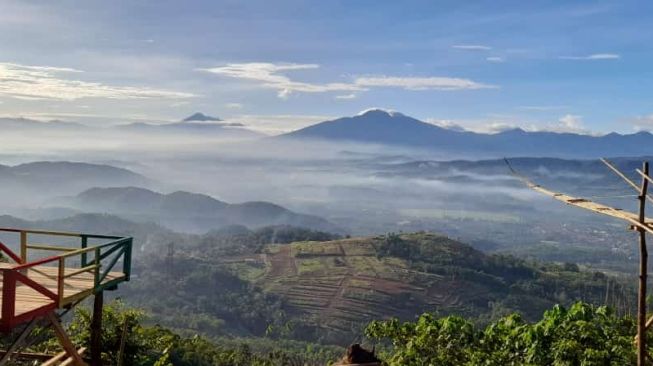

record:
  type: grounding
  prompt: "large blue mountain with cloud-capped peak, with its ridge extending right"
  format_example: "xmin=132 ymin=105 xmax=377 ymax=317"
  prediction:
xmin=278 ymin=109 xmax=653 ymax=158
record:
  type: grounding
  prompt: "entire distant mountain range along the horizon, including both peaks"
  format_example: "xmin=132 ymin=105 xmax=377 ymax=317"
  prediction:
xmin=5 ymin=109 xmax=653 ymax=158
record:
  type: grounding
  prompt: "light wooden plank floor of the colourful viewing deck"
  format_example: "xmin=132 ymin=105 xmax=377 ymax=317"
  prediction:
xmin=0 ymin=263 xmax=125 ymax=319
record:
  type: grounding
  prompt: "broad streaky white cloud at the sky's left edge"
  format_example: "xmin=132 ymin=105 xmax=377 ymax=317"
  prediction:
xmin=0 ymin=63 xmax=194 ymax=100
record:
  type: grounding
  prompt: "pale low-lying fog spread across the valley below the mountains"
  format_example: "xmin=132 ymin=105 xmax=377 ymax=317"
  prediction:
xmin=0 ymin=129 xmax=634 ymax=272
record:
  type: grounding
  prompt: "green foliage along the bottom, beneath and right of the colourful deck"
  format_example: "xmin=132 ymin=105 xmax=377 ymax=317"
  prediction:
xmin=12 ymin=301 xmax=341 ymax=366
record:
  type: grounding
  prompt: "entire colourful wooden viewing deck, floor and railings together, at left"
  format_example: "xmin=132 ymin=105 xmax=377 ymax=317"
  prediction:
xmin=0 ymin=228 xmax=132 ymax=331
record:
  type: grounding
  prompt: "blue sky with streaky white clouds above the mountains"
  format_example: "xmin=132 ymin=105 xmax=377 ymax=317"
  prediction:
xmin=0 ymin=0 xmax=653 ymax=134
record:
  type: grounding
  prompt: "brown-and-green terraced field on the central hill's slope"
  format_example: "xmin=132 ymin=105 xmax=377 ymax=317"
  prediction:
xmin=224 ymin=236 xmax=510 ymax=340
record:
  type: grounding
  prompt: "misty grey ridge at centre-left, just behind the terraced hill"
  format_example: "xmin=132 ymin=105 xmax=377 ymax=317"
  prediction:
xmin=68 ymin=187 xmax=340 ymax=232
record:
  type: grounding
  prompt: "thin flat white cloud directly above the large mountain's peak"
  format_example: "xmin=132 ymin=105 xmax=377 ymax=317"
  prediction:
xmin=355 ymin=76 xmax=497 ymax=90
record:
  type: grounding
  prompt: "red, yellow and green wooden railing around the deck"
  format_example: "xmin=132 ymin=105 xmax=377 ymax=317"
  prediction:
xmin=0 ymin=228 xmax=133 ymax=329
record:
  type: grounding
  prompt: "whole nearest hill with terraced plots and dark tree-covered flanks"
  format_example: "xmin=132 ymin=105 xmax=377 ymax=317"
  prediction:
xmin=125 ymin=233 xmax=632 ymax=344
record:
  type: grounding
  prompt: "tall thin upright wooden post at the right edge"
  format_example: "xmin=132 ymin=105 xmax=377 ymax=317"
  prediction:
xmin=637 ymin=162 xmax=648 ymax=366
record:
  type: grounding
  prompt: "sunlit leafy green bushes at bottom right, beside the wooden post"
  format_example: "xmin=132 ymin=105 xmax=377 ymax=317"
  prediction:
xmin=366 ymin=303 xmax=636 ymax=366
